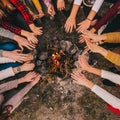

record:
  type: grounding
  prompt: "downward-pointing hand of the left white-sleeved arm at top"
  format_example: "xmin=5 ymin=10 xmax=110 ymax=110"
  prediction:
xmin=64 ymin=17 xmax=76 ymax=33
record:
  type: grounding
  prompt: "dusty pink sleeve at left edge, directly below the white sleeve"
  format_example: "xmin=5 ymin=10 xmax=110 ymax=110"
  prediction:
xmin=0 ymin=80 xmax=18 ymax=93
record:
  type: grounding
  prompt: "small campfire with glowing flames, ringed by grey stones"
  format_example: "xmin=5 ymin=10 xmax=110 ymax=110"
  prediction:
xmin=35 ymin=40 xmax=83 ymax=85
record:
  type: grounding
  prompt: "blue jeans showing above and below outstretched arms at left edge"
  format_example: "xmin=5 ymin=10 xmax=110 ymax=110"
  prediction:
xmin=0 ymin=42 xmax=20 ymax=70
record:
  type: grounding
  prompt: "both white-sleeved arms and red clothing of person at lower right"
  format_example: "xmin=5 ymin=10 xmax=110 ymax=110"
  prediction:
xmin=71 ymin=56 xmax=120 ymax=115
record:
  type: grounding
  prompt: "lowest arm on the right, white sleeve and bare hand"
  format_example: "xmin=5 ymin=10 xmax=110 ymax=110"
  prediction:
xmin=71 ymin=71 xmax=120 ymax=110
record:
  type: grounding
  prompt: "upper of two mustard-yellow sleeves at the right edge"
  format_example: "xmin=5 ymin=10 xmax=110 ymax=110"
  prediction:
xmin=103 ymin=32 xmax=120 ymax=43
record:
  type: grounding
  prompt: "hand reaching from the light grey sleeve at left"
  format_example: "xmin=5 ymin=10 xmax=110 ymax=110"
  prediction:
xmin=13 ymin=35 xmax=35 ymax=51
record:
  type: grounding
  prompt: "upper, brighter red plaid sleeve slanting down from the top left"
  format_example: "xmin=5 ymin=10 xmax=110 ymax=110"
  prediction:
xmin=10 ymin=0 xmax=33 ymax=25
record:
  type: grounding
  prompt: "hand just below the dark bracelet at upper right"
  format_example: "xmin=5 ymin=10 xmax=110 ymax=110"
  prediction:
xmin=77 ymin=19 xmax=91 ymax=33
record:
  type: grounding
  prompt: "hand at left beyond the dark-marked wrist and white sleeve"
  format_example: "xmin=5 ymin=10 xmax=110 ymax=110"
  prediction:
xmin=19 ymin=62 xmax=35 ymax=71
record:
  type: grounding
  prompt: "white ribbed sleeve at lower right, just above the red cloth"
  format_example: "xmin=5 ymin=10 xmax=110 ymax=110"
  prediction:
xmin=91 ymin=85 xmax=120 ymax=110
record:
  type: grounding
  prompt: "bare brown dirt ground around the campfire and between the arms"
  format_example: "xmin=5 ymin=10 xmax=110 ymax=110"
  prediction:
xmin=0 ymin=1 xmax=120 ymax=120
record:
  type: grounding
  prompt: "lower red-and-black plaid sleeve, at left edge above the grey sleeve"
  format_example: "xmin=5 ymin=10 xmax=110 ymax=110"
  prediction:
xmin=0 ymin=20 xmax=21 ymax=35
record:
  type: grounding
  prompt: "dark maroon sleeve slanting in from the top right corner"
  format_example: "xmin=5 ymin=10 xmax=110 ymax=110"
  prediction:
xmin=94 ymin=0 xmax=120 ymax=30
